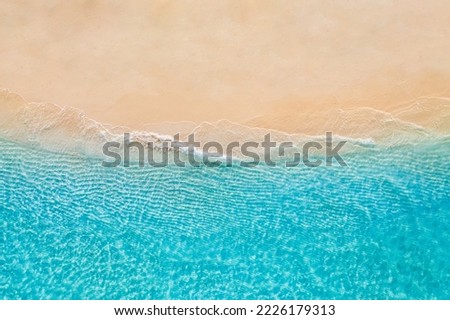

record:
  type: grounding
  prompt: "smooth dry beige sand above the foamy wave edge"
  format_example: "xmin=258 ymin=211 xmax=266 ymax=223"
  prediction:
xmin=0 ymin=0 xmax=450 ymax=135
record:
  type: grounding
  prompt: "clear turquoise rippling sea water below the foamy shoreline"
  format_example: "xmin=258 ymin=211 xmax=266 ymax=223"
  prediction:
xmin=0 ymin=139 xmax=450 ymax=299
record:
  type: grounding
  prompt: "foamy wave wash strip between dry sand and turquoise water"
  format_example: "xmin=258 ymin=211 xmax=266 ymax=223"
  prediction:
xmin=0 ymin=89 xmax=450 ymax=159
